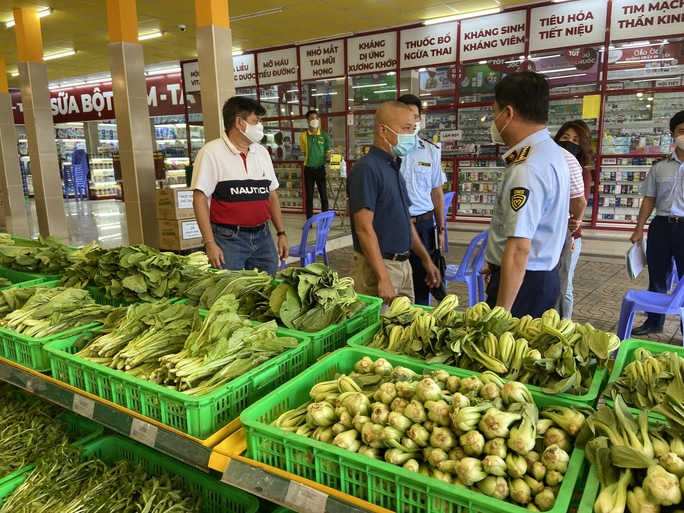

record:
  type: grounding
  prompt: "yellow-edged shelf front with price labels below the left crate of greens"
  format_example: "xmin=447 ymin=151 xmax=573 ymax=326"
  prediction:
xmin=0 ymin=358 xmax=222 ymax=470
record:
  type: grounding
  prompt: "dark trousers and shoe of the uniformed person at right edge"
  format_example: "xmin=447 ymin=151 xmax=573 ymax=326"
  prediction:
xmin=646 ymin=216 xmax=684 ymax=329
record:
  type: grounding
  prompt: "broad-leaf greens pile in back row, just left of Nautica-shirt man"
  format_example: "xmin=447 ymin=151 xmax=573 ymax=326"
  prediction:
xmin=60 ymin=244 xmax=209 ymax=302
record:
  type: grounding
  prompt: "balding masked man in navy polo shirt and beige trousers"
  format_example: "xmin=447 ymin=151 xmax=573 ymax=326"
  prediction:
xmin=347 ymin=101 xmax=440 ymax=304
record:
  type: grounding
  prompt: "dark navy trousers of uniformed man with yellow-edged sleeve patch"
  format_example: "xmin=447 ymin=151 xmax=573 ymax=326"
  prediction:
xmin=487 ymin=269 xmax=559 ymax=318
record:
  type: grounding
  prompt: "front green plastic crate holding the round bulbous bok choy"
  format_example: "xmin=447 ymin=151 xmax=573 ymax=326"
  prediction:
xmin=240 ymin=347 xmax=584 ymax=513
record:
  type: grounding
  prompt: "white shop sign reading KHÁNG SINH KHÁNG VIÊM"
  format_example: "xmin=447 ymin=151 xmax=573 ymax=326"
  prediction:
xmin=459 ymin=10 xmax=527 ymax=62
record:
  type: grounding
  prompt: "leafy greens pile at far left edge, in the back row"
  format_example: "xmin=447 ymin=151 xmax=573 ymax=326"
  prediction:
xmin=0 ymin=234 xmax=99 ymax=275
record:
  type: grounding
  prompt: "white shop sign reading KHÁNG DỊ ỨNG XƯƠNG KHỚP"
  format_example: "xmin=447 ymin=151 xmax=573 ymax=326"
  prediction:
xmin=347 ymin=32 xmax=397 ymax=75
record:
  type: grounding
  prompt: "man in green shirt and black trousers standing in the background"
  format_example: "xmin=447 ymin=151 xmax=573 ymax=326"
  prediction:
xmin=299 ymin=110 xmax=331 ymax=219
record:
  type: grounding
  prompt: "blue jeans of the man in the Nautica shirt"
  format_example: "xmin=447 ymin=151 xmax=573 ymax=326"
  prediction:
xmin=211 ymin=223 xmax=278 ymax=275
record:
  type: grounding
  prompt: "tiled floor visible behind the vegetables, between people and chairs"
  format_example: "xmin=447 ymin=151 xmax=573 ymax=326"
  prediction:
xmin=8 ymin=200 xmax=682 ymax=345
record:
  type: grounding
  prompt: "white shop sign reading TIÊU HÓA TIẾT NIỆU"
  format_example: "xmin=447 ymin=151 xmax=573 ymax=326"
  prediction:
xmin=530 ymin=0 xmax=606 ymax=52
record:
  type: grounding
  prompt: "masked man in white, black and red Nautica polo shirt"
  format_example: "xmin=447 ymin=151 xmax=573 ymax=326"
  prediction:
xmin=192 ymin=96 xmax=289 ymax=274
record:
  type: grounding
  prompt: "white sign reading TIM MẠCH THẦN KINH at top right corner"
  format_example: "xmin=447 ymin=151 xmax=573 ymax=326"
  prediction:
xmin=610 ymin=0 xmax=684 ymax=41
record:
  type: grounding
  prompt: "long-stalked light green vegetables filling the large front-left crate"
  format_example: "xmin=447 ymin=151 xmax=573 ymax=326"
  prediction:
xmin=76 ymin=294 xmax=297 ymax=396
